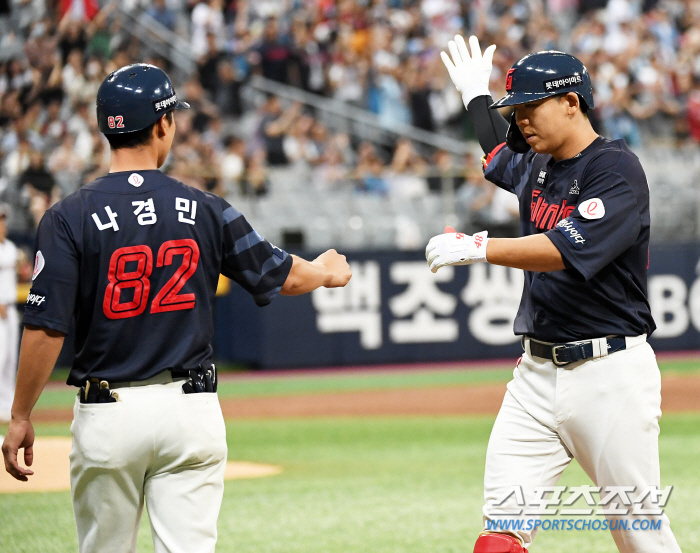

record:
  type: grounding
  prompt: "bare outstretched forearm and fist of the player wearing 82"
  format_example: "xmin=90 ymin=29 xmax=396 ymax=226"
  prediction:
xmin=280 ymin=250 xmax=352 ymax=296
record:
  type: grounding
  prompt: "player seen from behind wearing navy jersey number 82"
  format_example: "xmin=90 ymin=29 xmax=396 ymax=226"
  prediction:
xmin=2 ymin=64 xmax=351 ymax=553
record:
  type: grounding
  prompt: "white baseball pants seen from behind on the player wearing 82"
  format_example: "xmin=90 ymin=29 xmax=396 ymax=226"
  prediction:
xmin=70 ymin=373 xmax=227 ymax=553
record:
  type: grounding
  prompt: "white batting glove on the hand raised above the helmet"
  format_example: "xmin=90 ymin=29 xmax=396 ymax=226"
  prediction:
xmin=440 ymin=35 xmax=496 ymax=109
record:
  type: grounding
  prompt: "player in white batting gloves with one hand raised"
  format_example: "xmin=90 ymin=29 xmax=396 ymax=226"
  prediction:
xmin=426 ymin=36 xmax=680 ymax=553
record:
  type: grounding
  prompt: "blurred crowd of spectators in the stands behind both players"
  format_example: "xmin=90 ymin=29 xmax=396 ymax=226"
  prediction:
xmin=0 ymin=0 xmax=700 ymax=245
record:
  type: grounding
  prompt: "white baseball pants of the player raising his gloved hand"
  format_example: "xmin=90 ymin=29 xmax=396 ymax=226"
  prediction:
xmin=484 ymin=336 xmax=680 ymax=553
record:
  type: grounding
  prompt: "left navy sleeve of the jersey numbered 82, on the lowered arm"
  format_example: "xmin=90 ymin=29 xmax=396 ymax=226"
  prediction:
xmin=23 ymin=210 xmax=80 ymax=334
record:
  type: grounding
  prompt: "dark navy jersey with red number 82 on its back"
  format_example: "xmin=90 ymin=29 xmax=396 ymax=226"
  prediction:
xmin=24 ymin=170 xmax=292 ymax=386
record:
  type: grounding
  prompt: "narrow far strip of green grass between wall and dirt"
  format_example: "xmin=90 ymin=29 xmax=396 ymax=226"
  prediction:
xmin=36 ymin=359 xmax=700 ymax=409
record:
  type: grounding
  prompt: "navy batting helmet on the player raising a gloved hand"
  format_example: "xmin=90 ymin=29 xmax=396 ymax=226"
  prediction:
xmin=491 ymin=50 xmax=593 ymax=109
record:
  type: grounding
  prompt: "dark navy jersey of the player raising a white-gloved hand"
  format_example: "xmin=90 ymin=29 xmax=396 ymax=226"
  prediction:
xmin=484 ymin=137 xmax=656 ymax=342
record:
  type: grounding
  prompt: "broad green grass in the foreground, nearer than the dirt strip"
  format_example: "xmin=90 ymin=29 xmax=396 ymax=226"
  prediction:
xmin=0 ymin=414 xmax=700 ymax=553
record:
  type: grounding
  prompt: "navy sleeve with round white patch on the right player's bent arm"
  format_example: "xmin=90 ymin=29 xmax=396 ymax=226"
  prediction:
xmin=547 ymin=157 xmax=642 ymax=280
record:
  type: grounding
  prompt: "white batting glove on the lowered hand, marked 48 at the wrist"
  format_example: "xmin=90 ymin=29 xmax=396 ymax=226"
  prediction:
xmin=425 ymin=227 xmax=489 ymax=273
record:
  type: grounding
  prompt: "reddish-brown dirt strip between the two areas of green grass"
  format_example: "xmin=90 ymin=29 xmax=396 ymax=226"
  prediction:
xmin=32 ymin=375 xmax=700 ymax=422
